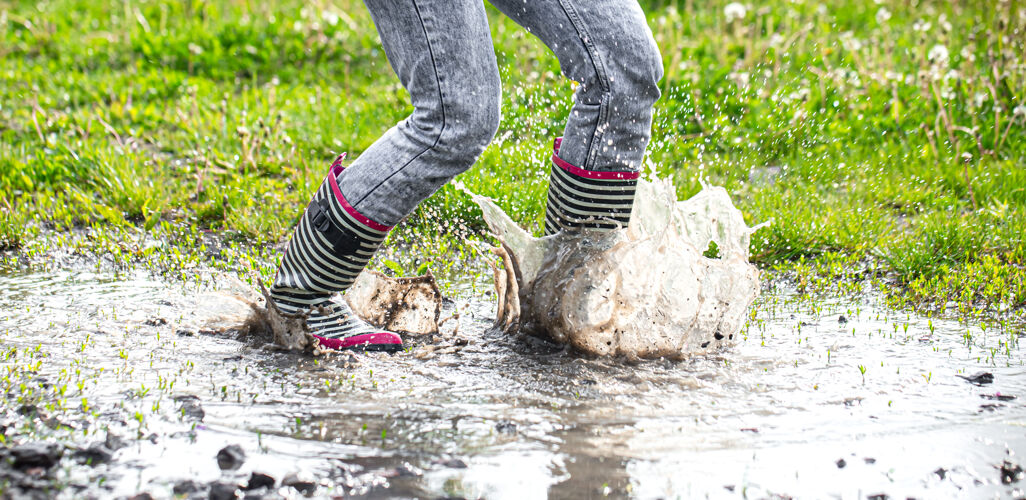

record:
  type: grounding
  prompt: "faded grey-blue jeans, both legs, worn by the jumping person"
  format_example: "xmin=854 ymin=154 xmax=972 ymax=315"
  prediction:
xmin=338 ymin=0 xmax=663 ymax=226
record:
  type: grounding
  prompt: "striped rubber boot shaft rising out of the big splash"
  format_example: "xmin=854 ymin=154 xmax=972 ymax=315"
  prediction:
xmin=545 ymin=139 xmax=640 ymax=236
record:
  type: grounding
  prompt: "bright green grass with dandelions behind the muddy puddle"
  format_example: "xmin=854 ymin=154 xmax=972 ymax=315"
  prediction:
xmin=0 ymin=0 xmax=1026 ymax=311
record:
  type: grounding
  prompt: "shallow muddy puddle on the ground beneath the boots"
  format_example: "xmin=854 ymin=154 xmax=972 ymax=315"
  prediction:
xmin=0 ymin=271 xmax=1026 ymax=499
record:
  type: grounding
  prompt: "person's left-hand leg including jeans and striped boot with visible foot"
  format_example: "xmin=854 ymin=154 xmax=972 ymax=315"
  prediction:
xmin=270 ymin=0 xmax=500 ymax=349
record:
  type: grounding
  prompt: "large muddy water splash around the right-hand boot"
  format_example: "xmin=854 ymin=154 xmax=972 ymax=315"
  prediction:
xmin=463 ymin=179 xmax=760 ymax=358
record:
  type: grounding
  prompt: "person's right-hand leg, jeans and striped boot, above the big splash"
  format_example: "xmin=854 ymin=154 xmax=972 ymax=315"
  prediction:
xmin=489 ymin=0 xmax=663 ymax=234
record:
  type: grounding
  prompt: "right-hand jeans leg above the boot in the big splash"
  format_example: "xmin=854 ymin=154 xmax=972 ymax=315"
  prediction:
xmin=489 ymin=0 xmax=663 ymax=171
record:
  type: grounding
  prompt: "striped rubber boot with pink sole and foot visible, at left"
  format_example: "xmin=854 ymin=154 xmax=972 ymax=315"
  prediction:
xmin=270 ymin=154 xmax=402 ymax=351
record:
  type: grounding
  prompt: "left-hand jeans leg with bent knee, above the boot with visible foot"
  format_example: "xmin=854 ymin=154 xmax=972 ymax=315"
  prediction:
xmin=339 ymin=0 xmax=501 ymax=226
